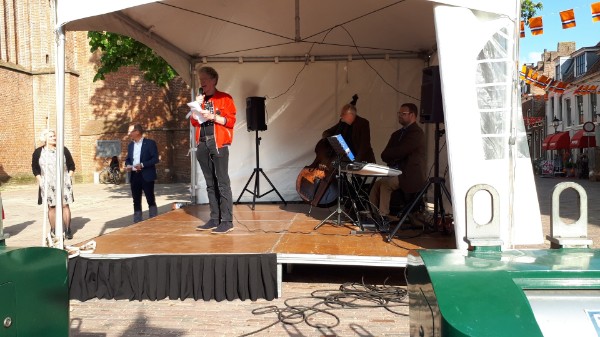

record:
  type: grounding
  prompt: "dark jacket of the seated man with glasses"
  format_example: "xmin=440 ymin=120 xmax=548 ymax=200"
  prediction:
xmin=381 ymin=122 xmax=427 ymax=193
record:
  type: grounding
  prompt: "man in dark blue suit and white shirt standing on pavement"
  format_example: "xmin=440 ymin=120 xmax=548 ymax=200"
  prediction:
xmin=125 ymin=124 xmax=159 ymax=223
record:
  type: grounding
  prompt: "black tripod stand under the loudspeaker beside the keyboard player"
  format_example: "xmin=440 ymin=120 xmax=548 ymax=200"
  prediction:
xmin=386 ymin=123 xmax=452 ymax=242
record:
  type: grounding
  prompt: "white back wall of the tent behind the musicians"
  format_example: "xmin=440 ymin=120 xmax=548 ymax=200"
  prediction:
xmin=209 ymin=59 xmax=425 ymax=201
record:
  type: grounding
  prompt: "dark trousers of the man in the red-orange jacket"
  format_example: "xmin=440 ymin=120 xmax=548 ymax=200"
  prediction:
xmin=196 ymin=138 xmax=233 ymax=222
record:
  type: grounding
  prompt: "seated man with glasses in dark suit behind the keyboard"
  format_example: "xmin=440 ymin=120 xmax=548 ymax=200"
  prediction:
xmin=369 ymin=103 xmax=427 ymax=221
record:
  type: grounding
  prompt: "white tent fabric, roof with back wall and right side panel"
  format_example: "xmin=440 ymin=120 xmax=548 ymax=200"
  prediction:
xmin=56 ymin=0 xmax=542 ymax=246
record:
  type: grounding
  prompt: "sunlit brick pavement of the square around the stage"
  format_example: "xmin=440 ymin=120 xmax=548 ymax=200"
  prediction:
xmin=2 ymin=177 xmax=600 ymax=337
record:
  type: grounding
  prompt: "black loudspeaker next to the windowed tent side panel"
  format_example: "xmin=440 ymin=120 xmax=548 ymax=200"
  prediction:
xmin=420 ymin=66 xmax=444 ymax=123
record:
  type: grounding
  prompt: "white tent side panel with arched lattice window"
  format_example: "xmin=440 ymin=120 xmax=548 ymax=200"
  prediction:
xmin=435 ymin=4 xmax=543 ymax=248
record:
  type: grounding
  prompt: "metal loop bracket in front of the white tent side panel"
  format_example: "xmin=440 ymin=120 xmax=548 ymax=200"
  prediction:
xmin=464 ymin=184 xmax=502 ymax=249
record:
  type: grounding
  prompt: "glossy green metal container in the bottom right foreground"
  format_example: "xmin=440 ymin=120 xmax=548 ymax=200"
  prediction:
xmin=407 ymin=247 xmax=600 ymax=337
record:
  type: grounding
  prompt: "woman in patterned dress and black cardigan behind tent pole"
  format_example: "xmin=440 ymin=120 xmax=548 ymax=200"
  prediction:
xmin=31 ymin=129 xmax=75 ymax=240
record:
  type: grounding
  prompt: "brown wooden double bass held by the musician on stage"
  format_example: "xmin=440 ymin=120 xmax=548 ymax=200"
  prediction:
xmin=296 ymin=94 xmax=358 ymax=207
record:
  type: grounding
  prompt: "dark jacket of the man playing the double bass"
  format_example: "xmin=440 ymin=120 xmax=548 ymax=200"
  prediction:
xmin=323 ymin=116 xmax=375 ymax=163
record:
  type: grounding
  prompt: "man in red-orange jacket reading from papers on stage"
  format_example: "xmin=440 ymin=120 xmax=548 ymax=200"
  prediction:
xmin=190 ymin=67 xmax=236 ymax=234
